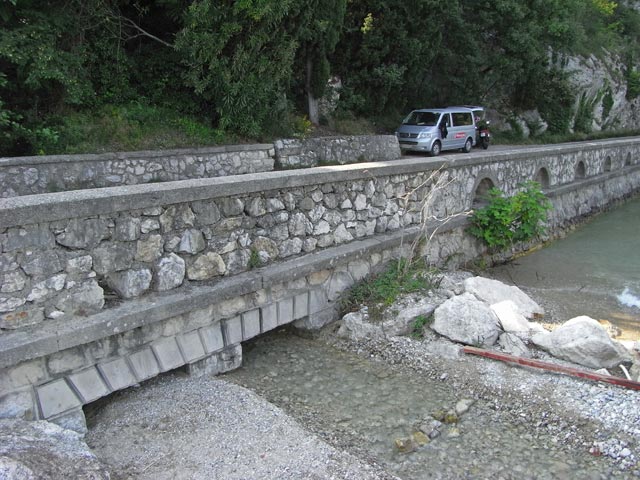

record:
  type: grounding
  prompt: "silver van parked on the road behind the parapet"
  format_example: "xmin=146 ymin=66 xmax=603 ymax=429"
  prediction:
xmin=396 ymin=107 xmax=476 ymax=156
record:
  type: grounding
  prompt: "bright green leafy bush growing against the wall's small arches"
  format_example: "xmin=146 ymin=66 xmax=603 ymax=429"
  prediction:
xmin=468 ymin=182 xmax=551 ymax=250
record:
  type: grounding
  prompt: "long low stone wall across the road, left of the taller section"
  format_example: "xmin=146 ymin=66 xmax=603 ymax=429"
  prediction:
xmin=0 ymin=144 xmax=274 ymax=197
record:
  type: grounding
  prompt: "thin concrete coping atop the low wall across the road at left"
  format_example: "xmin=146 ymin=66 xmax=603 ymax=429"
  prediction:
xmin=0 ymin=143 xmax=273 ymax=167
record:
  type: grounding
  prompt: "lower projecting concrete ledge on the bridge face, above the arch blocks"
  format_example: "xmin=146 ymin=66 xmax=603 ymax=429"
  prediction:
xmin=0 ymin=222 xmax=466 ymax=368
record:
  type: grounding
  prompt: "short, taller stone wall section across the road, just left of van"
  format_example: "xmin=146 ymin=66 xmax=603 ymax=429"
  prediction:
xmin=274 ymin=135 xmax=400 ymax=169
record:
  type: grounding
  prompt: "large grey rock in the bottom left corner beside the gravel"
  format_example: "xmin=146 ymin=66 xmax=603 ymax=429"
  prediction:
xmin=0 ymin=419 xmax=110 ymax=480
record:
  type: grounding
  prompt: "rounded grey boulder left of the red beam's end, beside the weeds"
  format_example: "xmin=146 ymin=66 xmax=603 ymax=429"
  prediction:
xmin=431 ymin=293 xmax=500 ymax=347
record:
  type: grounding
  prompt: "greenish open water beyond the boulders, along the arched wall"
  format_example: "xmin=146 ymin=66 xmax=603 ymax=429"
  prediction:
xmin=491 ymin=199 xmax=640 ymax=340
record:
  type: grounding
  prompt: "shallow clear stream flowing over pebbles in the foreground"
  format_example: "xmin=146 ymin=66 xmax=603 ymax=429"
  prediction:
xmin=225 ymin=332 xmax=612 ymax=480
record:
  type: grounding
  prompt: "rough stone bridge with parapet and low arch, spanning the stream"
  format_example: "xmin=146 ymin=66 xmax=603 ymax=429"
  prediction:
xmin=0 ymin=138 xmax=640 ymax=430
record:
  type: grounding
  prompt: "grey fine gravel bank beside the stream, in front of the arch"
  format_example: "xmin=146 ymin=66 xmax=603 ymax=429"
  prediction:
xmin=86 ymin=373 xmax=396 ymax=480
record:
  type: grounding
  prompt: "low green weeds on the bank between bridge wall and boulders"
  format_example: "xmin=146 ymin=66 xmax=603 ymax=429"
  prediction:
xmin=341 ymin=259 xmax=433 ymax=316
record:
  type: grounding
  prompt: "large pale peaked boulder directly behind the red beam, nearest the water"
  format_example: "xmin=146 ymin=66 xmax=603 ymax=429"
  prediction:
xmin=531 ymin=316 xmax=631 ymax=368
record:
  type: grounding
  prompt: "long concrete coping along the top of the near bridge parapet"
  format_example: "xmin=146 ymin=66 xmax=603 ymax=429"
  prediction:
xmin=0 ymin=137 xmax=640 ymax=229
